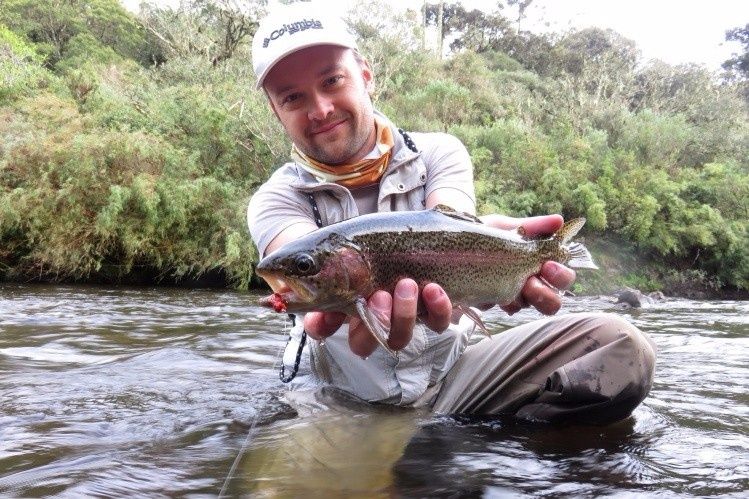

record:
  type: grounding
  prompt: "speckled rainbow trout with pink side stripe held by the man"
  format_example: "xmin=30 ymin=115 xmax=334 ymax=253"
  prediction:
xmin=256 ymin=206 xmax=598 ymax=354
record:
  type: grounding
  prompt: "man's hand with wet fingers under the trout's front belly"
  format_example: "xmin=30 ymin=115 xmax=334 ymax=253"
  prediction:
xmin=304 ymin=279 xmax=453 ymax=357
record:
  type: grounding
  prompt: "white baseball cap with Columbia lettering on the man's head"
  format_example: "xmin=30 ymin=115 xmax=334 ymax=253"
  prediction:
xmin=252 ymin=2 xmax=357 ymax=88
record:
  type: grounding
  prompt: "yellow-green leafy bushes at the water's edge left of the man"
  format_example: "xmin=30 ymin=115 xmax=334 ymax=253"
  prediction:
xmin=0 ymin=95 xmax=253 ymax=285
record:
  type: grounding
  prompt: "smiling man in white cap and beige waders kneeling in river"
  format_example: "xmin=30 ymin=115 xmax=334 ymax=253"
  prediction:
xmin=248 ymin=4 xmax=655 ymax=423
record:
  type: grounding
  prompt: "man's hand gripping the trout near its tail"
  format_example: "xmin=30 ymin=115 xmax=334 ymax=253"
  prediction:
xmin=481 ymin=215 xmax=576 ymax=315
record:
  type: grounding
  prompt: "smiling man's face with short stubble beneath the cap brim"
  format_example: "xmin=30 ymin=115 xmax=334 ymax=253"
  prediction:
xmin=264 ymin=45 xmax=375 ymax=165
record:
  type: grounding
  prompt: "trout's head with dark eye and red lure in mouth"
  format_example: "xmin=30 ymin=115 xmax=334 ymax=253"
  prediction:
xmin=255 ymin=234 xmax=371 ymax=312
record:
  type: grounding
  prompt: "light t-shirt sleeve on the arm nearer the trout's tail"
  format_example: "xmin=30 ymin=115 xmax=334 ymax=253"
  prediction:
xmin=422 ymin=133 xmax=476 ymax=205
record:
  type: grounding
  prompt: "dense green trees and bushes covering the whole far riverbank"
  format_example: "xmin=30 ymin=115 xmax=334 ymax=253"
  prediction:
xmin=0 ymin=0 xmax=749 ymax=290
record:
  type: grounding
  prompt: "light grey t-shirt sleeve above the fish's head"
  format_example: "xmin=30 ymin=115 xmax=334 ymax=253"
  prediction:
xmin=247 ymin=182 xmax=315 ymax=256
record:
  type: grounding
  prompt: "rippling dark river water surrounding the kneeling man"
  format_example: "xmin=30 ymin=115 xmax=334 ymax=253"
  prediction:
xmin=0 ymin=284 xmax=749 ymax=497
